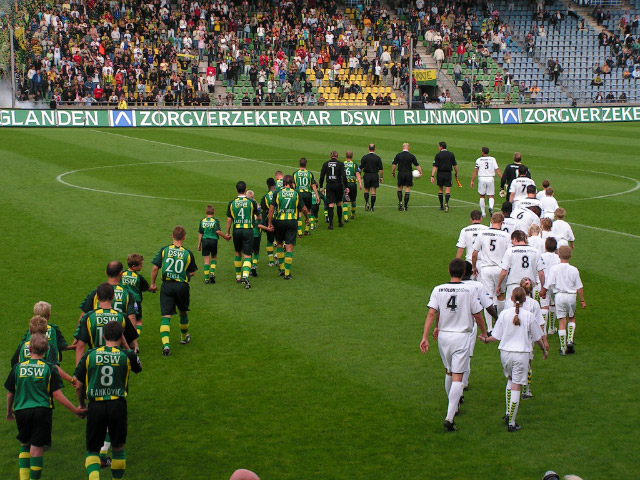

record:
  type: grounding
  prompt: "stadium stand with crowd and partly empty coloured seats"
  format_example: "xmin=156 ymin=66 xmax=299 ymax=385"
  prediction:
xmin=5 ymin=0 xmax=640 ymax=107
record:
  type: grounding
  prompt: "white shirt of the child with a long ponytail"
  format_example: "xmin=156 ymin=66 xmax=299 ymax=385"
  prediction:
xmin=491 ymin=307 xmax=542 ymax=353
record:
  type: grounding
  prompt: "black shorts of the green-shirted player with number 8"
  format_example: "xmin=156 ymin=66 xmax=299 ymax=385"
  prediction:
xmin=86 ymin=398 xmax=127 ymax=452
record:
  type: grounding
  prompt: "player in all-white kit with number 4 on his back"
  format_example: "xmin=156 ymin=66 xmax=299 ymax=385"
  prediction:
xmin=420 ymin=258 xmax=486 ymax=431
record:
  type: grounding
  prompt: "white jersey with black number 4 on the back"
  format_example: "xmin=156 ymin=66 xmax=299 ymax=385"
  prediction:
xmin=427 ymin=282 xmax=482 ymax=333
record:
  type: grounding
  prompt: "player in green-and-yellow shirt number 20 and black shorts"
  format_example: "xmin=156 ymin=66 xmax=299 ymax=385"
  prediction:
xmin=151 ymin=225 xmax=198 ymax=356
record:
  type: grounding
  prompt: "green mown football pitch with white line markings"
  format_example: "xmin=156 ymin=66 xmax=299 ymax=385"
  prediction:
xmin=0 ymin=123 xmax=640 ymax=480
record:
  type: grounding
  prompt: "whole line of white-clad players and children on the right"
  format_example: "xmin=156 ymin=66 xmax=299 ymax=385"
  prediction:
xmin=420 ymin=147 xmax=586 ymax=432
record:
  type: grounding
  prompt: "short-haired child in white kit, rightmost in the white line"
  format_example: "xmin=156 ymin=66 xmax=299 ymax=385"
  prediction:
xmin=540 ymin=245 xmax=587 ymax=355
